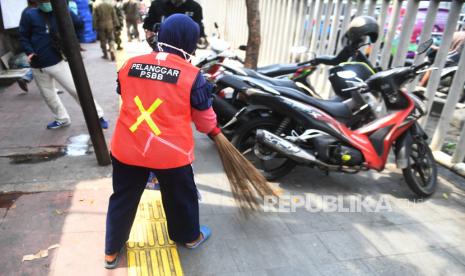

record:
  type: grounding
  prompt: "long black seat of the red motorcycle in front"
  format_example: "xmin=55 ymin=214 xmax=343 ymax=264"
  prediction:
xmin=273 ymin=87 xmax=352 ymax=123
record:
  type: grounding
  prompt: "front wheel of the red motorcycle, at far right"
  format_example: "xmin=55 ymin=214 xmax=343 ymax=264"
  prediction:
xmin=402 ymin=139 xmax=438 ymax=197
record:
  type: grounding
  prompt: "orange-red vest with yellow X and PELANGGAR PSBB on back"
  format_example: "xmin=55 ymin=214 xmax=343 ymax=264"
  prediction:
xmin=111 ymin=52 xmax=199 ymax=169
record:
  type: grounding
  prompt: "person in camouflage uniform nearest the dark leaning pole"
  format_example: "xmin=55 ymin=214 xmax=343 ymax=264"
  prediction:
xmin=93 ymin=0 xmax=120 ymax=61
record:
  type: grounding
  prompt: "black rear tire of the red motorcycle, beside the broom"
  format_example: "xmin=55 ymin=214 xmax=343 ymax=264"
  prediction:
xmin=231 ymin=117 xmax=297 ymax=180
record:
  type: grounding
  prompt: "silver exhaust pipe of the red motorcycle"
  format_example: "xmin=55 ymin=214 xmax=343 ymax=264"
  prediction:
xmin=256 ymin=129 xmax=339 ymax=169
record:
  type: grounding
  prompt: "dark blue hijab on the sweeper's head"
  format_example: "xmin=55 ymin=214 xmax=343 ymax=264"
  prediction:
xmin=158 ymin=13 xmax=200 ymax=58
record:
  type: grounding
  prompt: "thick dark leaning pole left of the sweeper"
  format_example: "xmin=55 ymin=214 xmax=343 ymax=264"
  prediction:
xmin=51 ymin=0 xmax=111 ymax=166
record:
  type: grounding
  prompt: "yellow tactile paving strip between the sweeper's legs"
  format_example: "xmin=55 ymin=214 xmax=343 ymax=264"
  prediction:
xmin=127 ymin=190 xmax=183 ymax=276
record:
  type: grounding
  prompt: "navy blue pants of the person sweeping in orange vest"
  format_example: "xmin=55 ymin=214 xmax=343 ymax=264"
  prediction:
xmin=105 ymin=156 xmax=200 ymax=255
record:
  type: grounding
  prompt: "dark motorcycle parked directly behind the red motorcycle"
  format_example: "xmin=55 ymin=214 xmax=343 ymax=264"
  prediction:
xmin=213 ymin=40 xmax=375 ymax=135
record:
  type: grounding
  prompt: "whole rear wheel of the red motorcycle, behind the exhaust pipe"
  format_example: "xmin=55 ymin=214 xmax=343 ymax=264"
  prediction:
xmin=232 ymin=117 xmax=296 ymax=180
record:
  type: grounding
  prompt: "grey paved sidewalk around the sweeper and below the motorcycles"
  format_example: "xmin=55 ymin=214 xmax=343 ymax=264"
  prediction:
xmin=0 ymin=39 xmax=465 ymax=276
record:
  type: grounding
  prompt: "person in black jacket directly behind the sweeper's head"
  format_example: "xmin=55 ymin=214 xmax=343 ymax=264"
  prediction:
xmin=143 ymin=0 xmax=205 ymax=40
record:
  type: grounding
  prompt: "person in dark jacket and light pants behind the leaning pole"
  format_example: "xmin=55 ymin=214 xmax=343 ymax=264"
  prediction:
xmin=19 ymin=0 xmax=108 ymax=129
